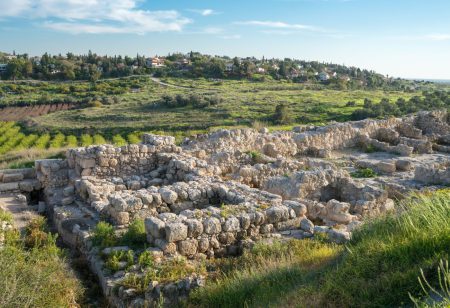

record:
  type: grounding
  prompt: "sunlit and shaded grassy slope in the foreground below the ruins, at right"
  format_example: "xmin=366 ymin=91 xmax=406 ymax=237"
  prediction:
xmin=191 ymin=190 xmax=450 ymax=307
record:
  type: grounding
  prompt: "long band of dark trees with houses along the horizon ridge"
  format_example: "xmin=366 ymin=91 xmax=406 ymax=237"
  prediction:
xmin=0 ymin=51 xmax=422 ymax=89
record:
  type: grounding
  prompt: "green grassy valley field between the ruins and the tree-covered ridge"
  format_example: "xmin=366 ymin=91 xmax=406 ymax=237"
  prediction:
xmin=34 ymin=79 xmax=413 ymax=132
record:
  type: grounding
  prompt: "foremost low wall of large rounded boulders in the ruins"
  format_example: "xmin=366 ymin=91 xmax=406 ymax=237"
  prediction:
xmin=145 ymin=201 xmax=306 ymax=257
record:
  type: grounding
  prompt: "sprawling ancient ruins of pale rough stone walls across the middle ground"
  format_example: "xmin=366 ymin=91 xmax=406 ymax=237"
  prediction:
xmin=0 ymin=111 xmax=450 ymax=307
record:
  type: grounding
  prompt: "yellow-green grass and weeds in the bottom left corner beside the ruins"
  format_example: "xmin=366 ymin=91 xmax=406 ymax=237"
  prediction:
xmin=0 ymin=211 xmax=83 ymax=308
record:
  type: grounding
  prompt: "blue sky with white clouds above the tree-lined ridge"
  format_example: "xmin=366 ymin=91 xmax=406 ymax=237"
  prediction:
xmin=0 ymin=0 xmax=450 ymax=79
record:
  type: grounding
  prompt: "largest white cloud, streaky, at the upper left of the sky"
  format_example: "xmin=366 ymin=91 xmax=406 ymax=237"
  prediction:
xmin=0 ymin=0 xmax=191 ymax=34
